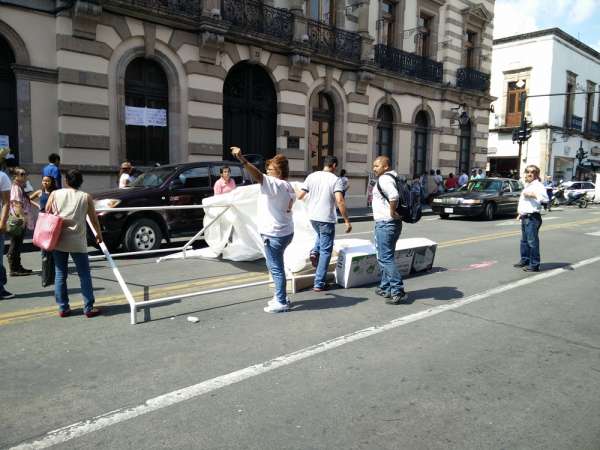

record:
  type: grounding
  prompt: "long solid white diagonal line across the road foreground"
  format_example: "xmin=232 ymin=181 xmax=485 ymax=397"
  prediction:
xmin=12 ymin=256 xmax=600 ymax=450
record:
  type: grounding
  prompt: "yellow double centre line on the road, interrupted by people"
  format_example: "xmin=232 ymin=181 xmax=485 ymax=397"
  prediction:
xmin=0 ymin=215 xmax=600 ymax=326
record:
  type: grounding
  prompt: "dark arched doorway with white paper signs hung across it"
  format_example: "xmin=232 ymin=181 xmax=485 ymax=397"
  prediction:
xmin=125 ymin=58 xmax=169 ymax=166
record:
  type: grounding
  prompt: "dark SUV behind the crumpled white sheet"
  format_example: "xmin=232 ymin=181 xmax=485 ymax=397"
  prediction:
xmin=88 ymin=161 xmax=252 ymax=252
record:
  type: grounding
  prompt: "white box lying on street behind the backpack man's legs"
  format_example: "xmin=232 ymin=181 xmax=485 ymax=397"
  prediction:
xmin=335 ymin=238 xmax=437 ymax=288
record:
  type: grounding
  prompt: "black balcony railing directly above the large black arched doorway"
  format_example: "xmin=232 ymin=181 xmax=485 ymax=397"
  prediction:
xmin=221 ymin=0 xmax=294 ymax=42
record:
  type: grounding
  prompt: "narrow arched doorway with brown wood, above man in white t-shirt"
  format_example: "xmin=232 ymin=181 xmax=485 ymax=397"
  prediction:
xmin=309 ymin=92 xmax=335 ymax=170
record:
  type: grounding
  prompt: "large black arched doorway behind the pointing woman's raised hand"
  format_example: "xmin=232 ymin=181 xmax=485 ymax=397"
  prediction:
xmin=223 ymin=62 xmax=277 ymax=159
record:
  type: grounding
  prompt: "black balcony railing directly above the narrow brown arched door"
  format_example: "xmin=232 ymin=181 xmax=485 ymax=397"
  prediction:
xmin=307 ymin=19 xmax=361 ymax=62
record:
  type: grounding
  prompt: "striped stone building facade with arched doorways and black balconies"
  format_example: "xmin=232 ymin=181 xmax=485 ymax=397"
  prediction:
xmin=0 ymin=0 xmax=493 ymax=206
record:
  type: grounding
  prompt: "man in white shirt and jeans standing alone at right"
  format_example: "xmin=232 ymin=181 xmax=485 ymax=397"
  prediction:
xmin=515 ymin=165 xmax=548 ymax=272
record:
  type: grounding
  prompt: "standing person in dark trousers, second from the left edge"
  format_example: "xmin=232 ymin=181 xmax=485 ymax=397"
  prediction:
xmin=6 ymin=167 xmax=35 ymax=277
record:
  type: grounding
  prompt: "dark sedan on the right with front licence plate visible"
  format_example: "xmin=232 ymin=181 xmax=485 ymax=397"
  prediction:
xmin=431 ymin=178 xmax=523 ymax=220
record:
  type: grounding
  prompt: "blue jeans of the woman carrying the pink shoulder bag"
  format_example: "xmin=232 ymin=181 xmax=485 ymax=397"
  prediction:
xmin=52 ymin=250 xmax=95 ymax=313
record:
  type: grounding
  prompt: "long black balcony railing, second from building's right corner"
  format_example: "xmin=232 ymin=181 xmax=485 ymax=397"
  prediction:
xmin=375 ymin=44 xmax=443 ymax=83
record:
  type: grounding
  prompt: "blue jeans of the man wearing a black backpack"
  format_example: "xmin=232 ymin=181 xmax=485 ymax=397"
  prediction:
xmin=374 ymin=220 xmax=404 ymax=295
